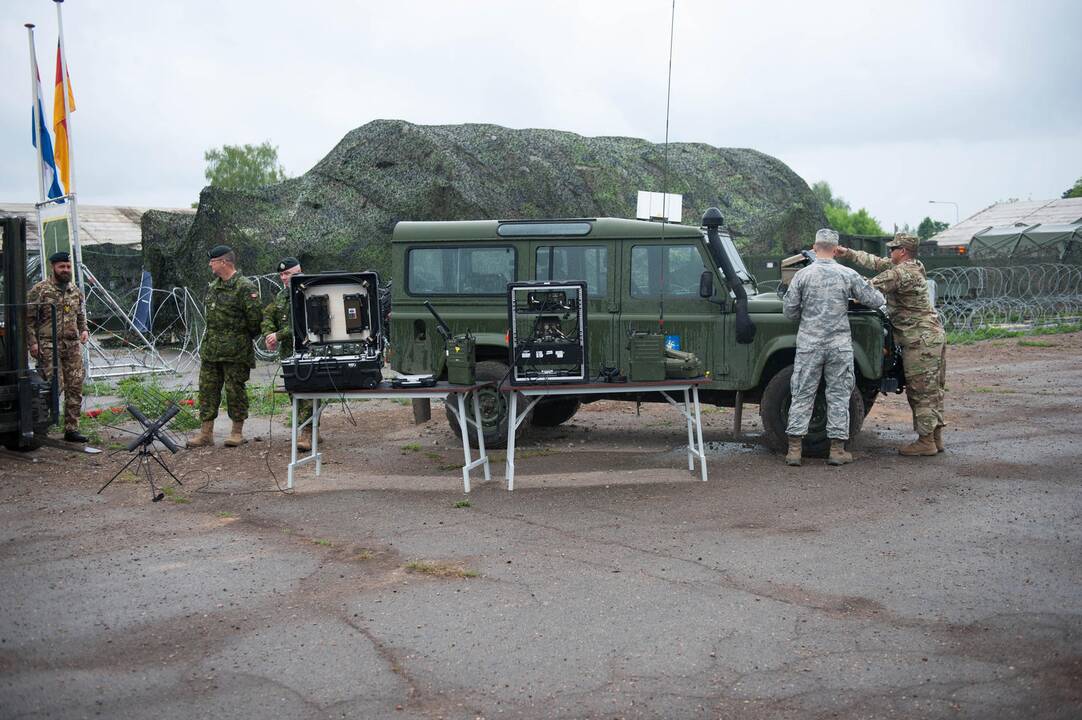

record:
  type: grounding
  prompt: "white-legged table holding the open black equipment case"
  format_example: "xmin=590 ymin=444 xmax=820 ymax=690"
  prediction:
xmin=286 ymin=382 xmax=491 ymax=493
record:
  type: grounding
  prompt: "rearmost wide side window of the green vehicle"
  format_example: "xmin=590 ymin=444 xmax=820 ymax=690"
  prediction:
xmin=406 ymin=247 xmax=515 ymax=294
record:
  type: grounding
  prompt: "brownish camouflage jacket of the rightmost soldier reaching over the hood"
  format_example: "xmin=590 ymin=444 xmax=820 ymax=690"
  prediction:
xmin=845 ymin=250 xmax=944 ymax=344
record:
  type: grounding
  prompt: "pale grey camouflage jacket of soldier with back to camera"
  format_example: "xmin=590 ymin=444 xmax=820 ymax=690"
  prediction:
xmin=781 ymin=259 xmax=883 ymax=350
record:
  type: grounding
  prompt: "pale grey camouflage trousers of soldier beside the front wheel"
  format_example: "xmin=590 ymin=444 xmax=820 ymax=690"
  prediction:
xmin=786 ymin=348 xmax=857 ymax=440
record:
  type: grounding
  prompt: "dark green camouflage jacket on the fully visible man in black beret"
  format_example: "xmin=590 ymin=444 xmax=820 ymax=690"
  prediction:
xmin=199 ymin=272 xmax=263 ymax=367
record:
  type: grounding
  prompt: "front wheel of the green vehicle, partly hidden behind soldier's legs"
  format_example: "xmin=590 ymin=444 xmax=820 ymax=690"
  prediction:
xmin=758 ymin=365 xmax=865 ymax=458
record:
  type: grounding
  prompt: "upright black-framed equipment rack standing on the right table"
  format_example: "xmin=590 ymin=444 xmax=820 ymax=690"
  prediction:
xmin=507 ymin=280 xmax=590 ymax=385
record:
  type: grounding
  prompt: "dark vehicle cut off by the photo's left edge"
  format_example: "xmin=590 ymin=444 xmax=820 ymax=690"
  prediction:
xmin=0 ymin=215 xmax=60 ymax=450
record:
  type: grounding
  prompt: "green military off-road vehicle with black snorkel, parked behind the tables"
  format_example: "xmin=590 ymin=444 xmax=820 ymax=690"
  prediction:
xmin=391 ymin=208 xmax=900 ymax=454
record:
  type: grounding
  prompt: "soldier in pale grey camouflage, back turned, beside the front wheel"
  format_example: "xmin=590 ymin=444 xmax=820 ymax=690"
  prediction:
xmin=782 ymin=230 xmax=884 ymax=466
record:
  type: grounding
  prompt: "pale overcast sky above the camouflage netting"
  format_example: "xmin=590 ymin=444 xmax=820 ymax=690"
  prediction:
xmin=0 ymin=0 xmax=1082 ymax=230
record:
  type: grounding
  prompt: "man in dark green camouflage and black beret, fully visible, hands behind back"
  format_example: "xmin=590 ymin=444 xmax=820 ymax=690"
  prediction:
xmin=188 ymin=245 xmax=263 ymax=447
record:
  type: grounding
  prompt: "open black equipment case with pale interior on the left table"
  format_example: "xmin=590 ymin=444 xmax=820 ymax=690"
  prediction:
xmin=281 ymin=272 xmax=385 ymax=392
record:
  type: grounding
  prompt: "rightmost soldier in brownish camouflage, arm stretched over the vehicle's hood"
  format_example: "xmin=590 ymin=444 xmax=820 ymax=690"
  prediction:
xmin=835 ymin=233 xmax=947 ymax=456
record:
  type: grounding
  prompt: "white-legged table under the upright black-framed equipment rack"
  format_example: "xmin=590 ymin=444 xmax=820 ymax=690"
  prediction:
xmin=500 ymin=378 xmax=710 ymax=490
